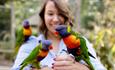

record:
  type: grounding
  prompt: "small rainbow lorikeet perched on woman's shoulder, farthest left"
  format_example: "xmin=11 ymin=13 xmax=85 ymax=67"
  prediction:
xmin=15 ymin=20 xmax=32 ymax=54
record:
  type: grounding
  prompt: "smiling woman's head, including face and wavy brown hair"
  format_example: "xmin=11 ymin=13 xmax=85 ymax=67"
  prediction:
xmin=39 ymin=0 xmax=72 ymax=37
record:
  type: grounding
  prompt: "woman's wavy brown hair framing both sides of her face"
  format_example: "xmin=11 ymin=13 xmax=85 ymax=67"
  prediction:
xmin=39 ymin=0 xmax=72 ymax=36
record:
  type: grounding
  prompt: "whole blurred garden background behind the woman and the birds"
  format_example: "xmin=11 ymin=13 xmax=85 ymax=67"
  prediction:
xmin=0 ymin=0 xmax=115 ymax=70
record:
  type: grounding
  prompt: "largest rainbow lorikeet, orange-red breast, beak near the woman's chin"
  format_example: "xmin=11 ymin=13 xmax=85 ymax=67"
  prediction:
xmin=56 ymin=25 xmax=95 ymax=70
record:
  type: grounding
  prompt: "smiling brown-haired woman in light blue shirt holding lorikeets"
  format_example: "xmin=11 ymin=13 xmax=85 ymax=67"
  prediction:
xmin=12 ymin=0 xmax=105 ymax=70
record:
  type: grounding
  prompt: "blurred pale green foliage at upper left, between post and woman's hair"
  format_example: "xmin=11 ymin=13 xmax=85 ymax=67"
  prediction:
xmin=14 ymin=0 xmax=41 ymax=25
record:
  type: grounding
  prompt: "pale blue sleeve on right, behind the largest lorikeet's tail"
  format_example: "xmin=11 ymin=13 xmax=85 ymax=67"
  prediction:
xmin=85 ymin=38 xmax=106 ymax=70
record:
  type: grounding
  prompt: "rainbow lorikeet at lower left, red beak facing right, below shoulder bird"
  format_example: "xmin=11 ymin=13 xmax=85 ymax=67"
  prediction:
xmin=20 ymin=40 xmax=52 ymax=70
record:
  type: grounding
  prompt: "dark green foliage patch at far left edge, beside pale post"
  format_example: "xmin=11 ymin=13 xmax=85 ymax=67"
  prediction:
xmin=0 ymin=6 xmax=11 ymax=41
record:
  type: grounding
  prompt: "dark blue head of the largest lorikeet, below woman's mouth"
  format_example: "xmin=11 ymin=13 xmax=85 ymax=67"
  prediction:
xmin=56 ymin=25 xmax=70 ymax=37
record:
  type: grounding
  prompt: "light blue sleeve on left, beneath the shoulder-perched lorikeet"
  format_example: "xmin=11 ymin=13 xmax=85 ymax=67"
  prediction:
xmin=11 ymin=37 xmax=37 ymax=70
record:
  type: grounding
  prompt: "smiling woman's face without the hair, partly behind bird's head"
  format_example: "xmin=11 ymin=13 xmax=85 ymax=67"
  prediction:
xmin=44 ymin=1 xmax=64 ymax=33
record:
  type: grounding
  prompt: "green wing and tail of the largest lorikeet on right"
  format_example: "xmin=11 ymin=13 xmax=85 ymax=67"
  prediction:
xmin=71 ymin=30 xmax=94 ymax=70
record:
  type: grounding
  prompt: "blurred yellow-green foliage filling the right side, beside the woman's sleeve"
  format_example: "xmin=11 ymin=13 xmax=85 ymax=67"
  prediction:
xmin=81 ymin=0 xmax=115 ymax=70
